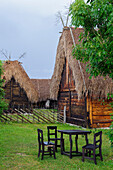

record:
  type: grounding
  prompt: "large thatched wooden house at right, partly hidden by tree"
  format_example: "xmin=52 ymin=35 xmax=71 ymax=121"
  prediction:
xmin=50 ymin=27 xmax=113 ymax=128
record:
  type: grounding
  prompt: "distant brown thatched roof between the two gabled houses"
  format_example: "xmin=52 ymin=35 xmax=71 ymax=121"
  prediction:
xmin=31 ymin=79 xmax=50 ymax=101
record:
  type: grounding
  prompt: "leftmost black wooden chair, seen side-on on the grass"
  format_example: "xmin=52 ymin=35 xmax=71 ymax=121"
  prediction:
xmin=37 ymin=129 xmax=56 ymax=160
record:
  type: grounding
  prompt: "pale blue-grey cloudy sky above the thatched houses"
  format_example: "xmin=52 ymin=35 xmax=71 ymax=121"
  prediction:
xmin=0 ymin=0 xmax=72 ymax=79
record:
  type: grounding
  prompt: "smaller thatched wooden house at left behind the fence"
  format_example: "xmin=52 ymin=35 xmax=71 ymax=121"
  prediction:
xmin=3 ymin=61 xmax=38 ymax=108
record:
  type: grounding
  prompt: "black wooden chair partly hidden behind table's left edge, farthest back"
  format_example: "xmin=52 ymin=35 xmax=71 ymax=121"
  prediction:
xmin=47 ymin=126 xmax=64 ymax=152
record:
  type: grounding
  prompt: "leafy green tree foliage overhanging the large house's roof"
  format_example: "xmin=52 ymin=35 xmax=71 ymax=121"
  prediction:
xmin=70 ymin=0 xmax=113 ymax=79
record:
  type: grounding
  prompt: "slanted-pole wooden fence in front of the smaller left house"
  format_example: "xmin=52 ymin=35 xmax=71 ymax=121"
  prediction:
xmin=0 ymin=109 xmax=64 ymax=123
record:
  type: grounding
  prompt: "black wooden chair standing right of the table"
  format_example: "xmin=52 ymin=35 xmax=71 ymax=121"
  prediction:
xmin=82 ymin=131 xmax=103 ymax=164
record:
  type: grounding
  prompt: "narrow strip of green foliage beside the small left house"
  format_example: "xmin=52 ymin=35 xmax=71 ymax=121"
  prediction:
xmin=0 ymin=60 xmax=8 ymax=115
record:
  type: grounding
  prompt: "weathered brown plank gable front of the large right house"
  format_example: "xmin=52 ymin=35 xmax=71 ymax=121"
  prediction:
xmin=58 ymin=60 xmax=86 ymax=126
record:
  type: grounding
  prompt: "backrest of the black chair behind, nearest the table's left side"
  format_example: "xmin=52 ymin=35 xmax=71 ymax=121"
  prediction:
xmin=47 ymin=126 xmax=57 ymax=141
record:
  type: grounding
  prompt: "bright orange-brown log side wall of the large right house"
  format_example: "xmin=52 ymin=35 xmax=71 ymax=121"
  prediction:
xmin=87 ymin=98 xmax=113 ymax=128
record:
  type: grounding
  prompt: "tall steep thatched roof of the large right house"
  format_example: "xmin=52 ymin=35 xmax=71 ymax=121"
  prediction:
xmin=50 ymin=28 xmax=113 ymax=100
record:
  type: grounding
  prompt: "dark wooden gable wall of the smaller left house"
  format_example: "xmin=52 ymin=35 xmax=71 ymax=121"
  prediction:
xmin=4 ymin=77 xmax=30 ymax=108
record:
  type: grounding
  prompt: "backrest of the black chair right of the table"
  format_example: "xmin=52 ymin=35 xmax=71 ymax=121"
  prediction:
xmin=94 ymin=131 xmax=102 ymax=146
